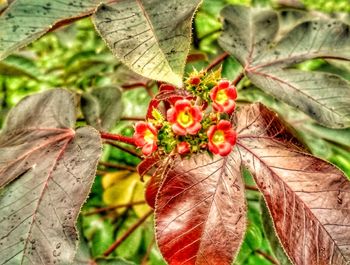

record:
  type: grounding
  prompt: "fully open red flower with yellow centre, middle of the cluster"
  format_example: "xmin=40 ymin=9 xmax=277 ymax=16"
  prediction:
xmin=167 ymin=99 xmax=203 ymax=135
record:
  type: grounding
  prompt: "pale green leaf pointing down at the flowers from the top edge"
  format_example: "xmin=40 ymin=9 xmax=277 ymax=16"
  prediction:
xmin=93 ymin=0 xmax=201 ymax=86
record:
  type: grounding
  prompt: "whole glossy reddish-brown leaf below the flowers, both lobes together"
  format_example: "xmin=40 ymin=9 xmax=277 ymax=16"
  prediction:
xmin=154 ymin=104 xmax=350 ymax=265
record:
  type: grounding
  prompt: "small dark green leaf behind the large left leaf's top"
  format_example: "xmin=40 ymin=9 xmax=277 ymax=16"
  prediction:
xmin=81 ymin=86 xmax=123 ymax=131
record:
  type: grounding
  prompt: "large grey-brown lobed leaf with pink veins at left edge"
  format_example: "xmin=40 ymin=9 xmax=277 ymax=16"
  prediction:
xmin=0 ymin=89 xmax=101 ymax=264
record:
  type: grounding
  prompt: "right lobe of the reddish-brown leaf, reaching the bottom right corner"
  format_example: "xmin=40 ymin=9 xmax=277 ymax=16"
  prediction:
xmin=237 ymin=104 xmax=350 ymax=265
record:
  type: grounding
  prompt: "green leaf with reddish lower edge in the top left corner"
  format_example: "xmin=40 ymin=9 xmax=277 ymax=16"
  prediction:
xmin=0 ymin=0 xmax=101 ymax=60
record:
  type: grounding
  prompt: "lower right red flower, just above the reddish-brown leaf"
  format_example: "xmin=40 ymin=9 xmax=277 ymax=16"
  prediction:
xmin=207 ymin=120 xmax=237 ymax=156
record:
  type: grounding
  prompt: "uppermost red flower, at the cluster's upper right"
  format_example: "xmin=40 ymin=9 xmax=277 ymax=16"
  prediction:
xmin=210 ymin=80 xmax=237 ymax=114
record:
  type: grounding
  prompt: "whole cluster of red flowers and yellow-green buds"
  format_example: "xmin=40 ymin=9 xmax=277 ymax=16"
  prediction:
xmin=134 ymin=69 xmax=237 ymax=156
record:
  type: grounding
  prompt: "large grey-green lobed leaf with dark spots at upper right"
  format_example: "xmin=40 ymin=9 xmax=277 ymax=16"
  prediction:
xmin=219 ymin=6 xmax=350 ymax=127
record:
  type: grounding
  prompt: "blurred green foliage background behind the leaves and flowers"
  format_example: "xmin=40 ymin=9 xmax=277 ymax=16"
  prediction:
xmin=0 ymin=0 xmax=350 ymax=265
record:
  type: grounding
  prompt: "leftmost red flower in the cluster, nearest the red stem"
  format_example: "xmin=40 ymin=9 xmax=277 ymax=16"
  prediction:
xmin=133 ymin=121 xmax=157 ymax=156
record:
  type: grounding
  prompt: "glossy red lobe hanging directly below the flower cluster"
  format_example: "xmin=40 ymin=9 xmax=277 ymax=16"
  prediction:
xmin=155 ymin=152 xmax=246 ymax=265
